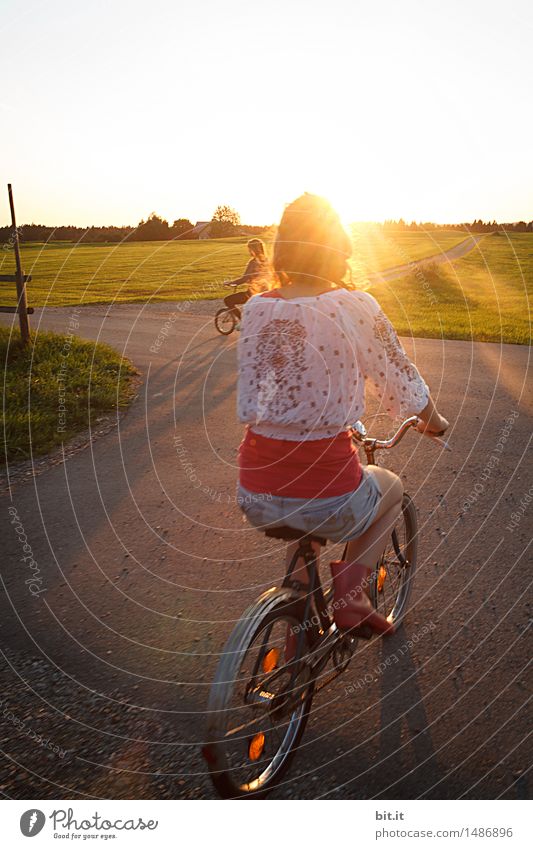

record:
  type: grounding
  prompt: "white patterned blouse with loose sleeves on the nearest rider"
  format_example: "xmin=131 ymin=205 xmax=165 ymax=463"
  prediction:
xmin=237 ymin=289 xmax=429 ymax=441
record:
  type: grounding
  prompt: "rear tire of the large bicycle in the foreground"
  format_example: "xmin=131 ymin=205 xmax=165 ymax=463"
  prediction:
xmin=203 ymin=588 xmax=315 ymax=799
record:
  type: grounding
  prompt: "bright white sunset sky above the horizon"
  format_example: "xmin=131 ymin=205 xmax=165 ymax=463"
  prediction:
xmin=0 ymin=0 xmax=533 ymax=226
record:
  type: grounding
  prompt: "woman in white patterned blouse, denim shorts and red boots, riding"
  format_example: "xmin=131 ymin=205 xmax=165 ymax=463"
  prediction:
xmin=238 ymin=194 xmax=448 ymax=633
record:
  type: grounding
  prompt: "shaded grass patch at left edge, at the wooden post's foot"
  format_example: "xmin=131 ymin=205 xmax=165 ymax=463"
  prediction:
xmin=0 ymin=327 xmax=136 ymax=466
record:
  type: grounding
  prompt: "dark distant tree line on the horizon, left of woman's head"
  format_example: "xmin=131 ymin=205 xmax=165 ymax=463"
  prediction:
xmin=0 ymin=205 xmax=266 ymax=244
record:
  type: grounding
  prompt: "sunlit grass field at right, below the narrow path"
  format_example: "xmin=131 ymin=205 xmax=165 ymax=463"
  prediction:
xmin=369 ymin=233 xmax=533 ymax=345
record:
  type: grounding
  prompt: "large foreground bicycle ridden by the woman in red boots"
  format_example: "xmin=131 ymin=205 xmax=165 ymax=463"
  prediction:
xmin=202 ymin=416 xmax=426 ymax=799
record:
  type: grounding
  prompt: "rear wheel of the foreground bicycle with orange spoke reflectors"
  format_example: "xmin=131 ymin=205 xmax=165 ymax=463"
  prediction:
xmin=203 ymin=589 xmax=314 ymax=799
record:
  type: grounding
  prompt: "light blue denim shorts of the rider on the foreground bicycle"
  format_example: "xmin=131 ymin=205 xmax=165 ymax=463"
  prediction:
xmin=237 ymin=468 xmax=381 ymax=542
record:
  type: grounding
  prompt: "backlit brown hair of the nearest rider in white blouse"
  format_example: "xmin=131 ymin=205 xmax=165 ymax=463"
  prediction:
xmin=273 ymin=193 xmax=352 ymax=286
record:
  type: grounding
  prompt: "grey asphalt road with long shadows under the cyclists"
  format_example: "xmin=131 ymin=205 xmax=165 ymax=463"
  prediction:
xmin=0 ymin=304 xmax=533 ymax=799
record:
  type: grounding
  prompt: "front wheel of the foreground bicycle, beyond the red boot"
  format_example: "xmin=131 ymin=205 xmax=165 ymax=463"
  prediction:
xmin=370 ymin=494 xmax=418 ymax=625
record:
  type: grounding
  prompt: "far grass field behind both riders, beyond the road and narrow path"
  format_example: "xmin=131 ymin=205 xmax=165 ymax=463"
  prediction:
xmin=0 ymin=228 xmax=465 ymax=306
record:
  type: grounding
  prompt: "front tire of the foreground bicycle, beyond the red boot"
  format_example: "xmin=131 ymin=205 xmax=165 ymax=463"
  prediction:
xmin=370 ymin=493 xmax=418 ymax=625
